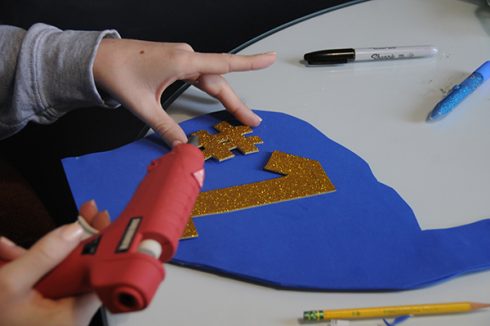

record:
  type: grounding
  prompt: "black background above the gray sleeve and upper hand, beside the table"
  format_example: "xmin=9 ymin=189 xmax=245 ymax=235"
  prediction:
xmin=0 ymin=0 xmax=346 ymax=52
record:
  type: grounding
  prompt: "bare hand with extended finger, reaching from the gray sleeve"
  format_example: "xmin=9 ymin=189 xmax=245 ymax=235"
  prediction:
xmin=93 ymin=39 xmax=276 ymax=146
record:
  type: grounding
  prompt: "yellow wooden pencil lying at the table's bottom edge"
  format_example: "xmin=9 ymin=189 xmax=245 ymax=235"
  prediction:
xmin=303 ymin=302 xmax=490 ymax=321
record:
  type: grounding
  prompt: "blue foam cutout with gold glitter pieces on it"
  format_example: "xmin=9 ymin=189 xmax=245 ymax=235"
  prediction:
xmin=63 ymin=111 xmax=490 ymax=290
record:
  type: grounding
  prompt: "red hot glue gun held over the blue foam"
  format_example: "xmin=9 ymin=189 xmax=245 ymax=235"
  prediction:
xmin=0 ymin=144 xmax=204 ymax=318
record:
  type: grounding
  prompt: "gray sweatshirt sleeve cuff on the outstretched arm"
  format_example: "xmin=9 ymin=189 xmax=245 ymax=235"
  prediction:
xmin=0 ymin=24 xmax=120 ymax=139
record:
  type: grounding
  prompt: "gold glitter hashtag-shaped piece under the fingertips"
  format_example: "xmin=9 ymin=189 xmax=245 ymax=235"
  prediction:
xmin=192 ymin=121 xmax=263 ymax=162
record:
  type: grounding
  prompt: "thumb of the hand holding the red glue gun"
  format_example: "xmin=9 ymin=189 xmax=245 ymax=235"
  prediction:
xmin=0 ymin=222 xmax=84 ymax=293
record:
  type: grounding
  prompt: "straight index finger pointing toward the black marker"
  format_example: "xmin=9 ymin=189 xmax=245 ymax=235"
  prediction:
xmin=189 ymin=52 xmax=276 ymax=75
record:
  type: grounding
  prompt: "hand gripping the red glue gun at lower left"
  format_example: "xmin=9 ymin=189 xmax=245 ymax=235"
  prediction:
xmin=0 ymin=201 xmax=109 ymax=326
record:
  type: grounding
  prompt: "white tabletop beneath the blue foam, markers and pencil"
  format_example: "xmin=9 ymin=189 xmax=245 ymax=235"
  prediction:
xmin=108 ymin=0 xmax=490 ymax=326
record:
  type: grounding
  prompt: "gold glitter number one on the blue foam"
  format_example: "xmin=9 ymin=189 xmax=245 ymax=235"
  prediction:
xmin=182 ymin=151 xmax=335 ymax=239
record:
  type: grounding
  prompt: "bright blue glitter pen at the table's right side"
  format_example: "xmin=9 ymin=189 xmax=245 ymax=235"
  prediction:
xmin=427 ymin=61 xmax=490 ymax=121
